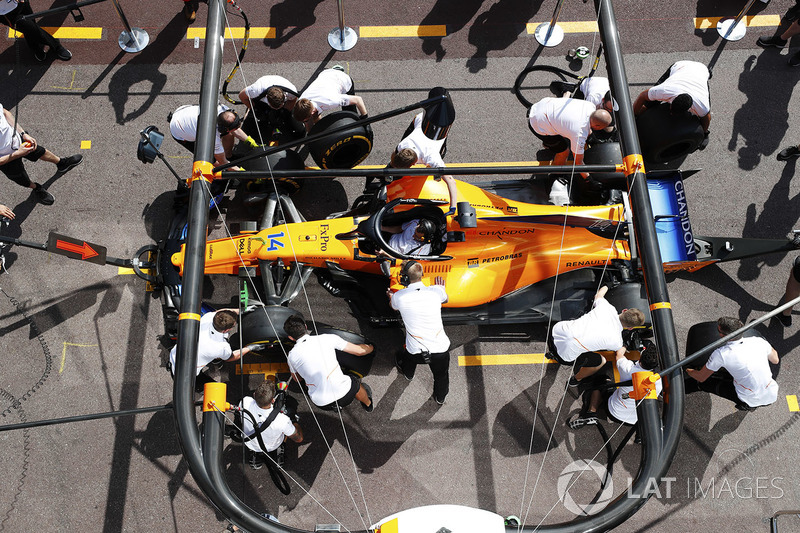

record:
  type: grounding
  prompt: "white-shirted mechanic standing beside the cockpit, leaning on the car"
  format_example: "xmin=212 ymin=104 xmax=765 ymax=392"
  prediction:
xmin=387 ymin=261 xmax=450 ymax=405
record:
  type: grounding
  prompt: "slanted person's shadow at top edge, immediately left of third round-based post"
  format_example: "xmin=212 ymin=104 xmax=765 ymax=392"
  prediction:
xmin=467 ymin=0 xmax=542 ymax=73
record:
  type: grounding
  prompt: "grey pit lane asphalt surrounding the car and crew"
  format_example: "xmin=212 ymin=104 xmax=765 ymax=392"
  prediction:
xmin=0 ymin=0 xmax=800 ymax=531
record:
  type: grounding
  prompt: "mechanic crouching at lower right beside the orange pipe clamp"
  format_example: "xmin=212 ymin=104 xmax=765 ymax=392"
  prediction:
xmin=567 ymin=340 xmax=662 ymax=429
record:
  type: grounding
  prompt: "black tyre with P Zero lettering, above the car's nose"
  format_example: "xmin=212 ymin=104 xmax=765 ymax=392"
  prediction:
xmin=308 ymin=111 xmax=372 ymax=169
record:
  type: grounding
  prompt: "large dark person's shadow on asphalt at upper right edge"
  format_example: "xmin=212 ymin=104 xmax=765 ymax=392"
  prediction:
xmin=728 ymin=50 xmax=798 ymax=170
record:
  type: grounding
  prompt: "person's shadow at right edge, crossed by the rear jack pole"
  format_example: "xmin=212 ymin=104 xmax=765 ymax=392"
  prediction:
xmin=738 ymin=160 xmax=800 ymax=281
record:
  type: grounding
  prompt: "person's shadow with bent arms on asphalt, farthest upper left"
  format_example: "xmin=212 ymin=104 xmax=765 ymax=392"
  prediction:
xmin=107 ymin=11 xmax=186 ymax=124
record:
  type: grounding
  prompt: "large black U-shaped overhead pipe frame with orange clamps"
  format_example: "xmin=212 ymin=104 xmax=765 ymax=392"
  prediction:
xmin=173 ymin=0 xmax=684 ymax=533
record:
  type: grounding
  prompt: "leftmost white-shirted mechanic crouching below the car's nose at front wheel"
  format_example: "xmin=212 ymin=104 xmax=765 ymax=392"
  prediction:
xmin=168 ymin=309 xmax=266 ymax=390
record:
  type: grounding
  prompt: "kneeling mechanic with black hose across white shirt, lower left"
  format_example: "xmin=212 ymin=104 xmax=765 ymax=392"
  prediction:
xmin=239 ymin=380 xmax=303 ymax=470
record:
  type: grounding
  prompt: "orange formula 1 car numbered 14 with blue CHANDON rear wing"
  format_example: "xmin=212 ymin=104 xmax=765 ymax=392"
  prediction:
xmin=161 ymin=171 xmax=794 ymax=332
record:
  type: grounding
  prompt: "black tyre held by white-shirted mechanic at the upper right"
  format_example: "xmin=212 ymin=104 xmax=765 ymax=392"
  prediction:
xmin=636 ymin=104 xmax=705 ymax=162
